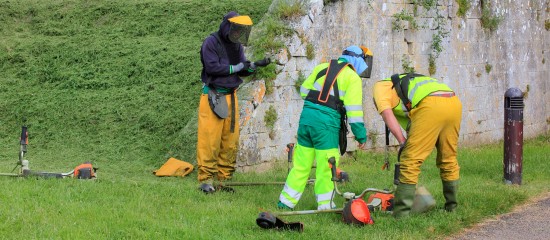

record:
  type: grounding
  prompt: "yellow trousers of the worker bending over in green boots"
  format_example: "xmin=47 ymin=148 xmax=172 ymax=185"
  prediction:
xmin=399 ymin=96 xmax=462 ymax=184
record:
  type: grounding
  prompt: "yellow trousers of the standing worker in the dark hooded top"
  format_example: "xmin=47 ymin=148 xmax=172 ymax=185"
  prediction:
xmin=197 ymin=93 xmax=239 ymax=183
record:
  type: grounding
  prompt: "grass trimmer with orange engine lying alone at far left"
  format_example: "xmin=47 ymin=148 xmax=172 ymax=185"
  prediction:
xmin=0 ymin=126 xmax=97 ymax=179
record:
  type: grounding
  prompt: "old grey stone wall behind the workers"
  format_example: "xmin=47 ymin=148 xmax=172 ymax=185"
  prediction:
xmin=238 ymin=0 xmax=550 ymax=171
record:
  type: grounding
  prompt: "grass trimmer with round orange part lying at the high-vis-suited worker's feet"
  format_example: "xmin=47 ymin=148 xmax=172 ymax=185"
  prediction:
xmin=256 ymin=157 xmax=391 ymax=232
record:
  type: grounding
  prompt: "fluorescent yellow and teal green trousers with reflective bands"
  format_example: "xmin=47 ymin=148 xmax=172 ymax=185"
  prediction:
xmin=279 ymin=125 xmax=340 ymax=209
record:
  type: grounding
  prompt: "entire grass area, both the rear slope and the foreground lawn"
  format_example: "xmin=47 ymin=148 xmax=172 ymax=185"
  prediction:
xmin=0 ymin=0 xmax=550 ymax=239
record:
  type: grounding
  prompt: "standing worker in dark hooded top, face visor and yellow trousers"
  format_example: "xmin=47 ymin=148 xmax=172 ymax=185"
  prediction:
xmin=197 ymin=12 xmax=270 ymax=193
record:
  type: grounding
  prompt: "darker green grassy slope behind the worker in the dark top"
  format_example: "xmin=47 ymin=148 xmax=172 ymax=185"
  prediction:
xmin=0 ymin=0 xmax=274 ymax=174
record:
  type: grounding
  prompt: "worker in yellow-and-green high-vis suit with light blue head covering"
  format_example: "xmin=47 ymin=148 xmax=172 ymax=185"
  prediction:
xmin=278 ymin=46 xmax=367 ymax=210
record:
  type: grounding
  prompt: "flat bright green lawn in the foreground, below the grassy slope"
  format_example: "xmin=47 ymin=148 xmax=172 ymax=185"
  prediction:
xmin=0 ymin=136 xmax=550 ymax=239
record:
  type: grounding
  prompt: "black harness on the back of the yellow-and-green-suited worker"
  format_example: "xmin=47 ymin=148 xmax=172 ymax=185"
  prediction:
xmin=305 ymin=60 xmax=351 ymax=155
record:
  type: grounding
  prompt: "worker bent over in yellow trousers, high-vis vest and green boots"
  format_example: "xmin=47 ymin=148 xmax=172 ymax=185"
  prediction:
xmin=373 ymin=73 xmax=462 ymax=218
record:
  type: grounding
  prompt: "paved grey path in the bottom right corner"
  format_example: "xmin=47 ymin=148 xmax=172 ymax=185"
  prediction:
xmin=449 ymin=193 xmax=550 ymax=240
